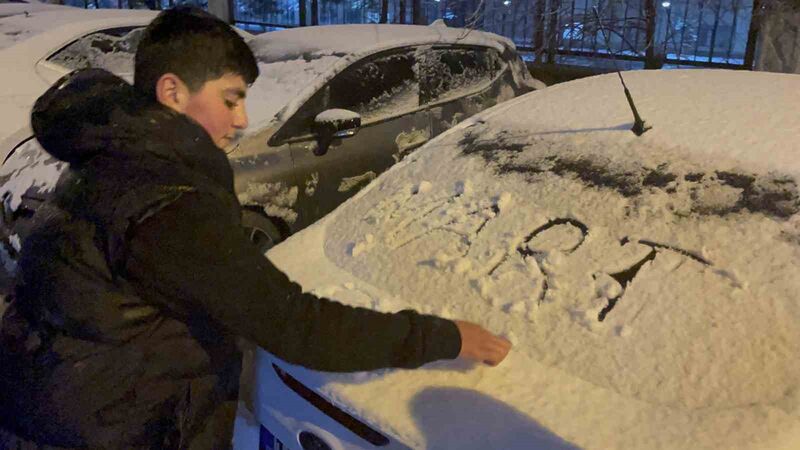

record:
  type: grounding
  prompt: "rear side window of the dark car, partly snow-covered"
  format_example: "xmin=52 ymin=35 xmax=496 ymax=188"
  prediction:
xmin=419 ymin=47 xmax=503 ymax=104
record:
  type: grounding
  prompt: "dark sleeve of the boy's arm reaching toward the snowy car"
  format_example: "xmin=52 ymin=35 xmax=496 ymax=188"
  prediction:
xmin=126 ymin=193 xmax=461 ymax=372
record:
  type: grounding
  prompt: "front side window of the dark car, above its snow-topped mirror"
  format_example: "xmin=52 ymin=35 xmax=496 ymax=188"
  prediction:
xmin=275 ymin=48 xmax=420 ymax=141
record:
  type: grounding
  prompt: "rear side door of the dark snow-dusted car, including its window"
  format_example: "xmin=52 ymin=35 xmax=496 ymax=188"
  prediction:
xmin=419 ymin=45 xmax=515 ymax=136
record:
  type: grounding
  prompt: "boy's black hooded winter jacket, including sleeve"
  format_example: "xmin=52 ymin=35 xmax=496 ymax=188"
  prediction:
xmin=0 ymin=70 xmax=461 ymax=449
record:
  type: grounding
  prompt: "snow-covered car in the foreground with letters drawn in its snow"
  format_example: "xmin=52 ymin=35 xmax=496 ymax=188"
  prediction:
xmin=236 ymin=70 xmax=800 ymax=450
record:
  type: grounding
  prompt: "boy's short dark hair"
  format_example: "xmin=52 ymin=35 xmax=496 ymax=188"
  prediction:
xmin=134 ymin=6 xmax=258 ymax=98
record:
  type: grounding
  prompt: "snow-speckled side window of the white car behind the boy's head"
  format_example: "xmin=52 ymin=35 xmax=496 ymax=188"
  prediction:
xmin=47 ymin=27 xmax=144 ymax=74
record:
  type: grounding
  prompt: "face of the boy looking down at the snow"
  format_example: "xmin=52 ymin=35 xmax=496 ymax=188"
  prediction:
xmin=182 ymin=73 xmax=247 ymax=148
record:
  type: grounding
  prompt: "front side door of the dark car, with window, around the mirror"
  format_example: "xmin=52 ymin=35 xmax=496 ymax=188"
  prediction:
xmin=271 ymin=47 xmax=430 ymax=229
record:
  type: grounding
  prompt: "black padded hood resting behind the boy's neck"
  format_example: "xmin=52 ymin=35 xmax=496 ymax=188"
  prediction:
xmin=31 ymin=69 xmax=233 ymax=190
